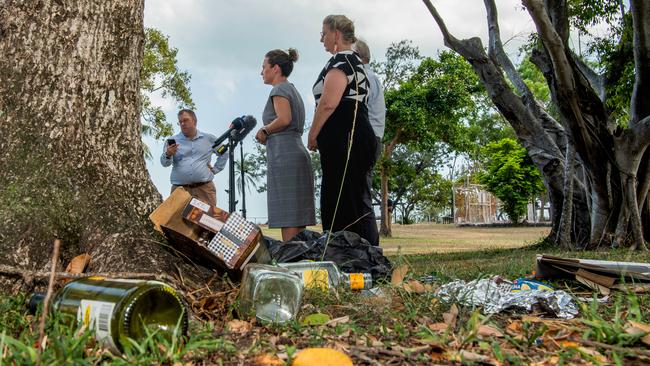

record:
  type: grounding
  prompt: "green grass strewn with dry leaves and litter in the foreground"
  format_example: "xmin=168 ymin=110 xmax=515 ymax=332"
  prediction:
xmin=0 ymin=239 xmax=650 ymax=365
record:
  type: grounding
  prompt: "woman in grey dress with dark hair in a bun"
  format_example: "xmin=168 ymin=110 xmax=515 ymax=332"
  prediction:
xmin=255 ymin=48 xmax=316 ymax=241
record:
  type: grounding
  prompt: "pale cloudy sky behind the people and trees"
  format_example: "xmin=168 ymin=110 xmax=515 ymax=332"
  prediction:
xmin=144 ymin=0 xmax=533 ymax=223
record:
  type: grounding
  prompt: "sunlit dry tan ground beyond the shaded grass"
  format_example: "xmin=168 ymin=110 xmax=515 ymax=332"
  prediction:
xmin=262 ymin=223 xmax=551 ymax=254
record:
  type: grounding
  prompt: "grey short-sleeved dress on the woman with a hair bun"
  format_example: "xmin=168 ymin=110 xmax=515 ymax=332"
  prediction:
xmin=262 ymin=82 xmax=316 ymax=228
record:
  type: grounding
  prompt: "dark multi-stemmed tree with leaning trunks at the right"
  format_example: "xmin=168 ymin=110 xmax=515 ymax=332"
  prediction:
xmin=423 ymin=0 xmax=650 ymax=248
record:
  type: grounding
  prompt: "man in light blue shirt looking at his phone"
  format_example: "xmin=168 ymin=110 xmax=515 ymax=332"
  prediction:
xmin=160 ymin=109 xmax=228 ymax=206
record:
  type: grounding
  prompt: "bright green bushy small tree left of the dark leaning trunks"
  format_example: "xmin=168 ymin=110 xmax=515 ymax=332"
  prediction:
xmin=479 ymin=138 xmax=544 ymax=223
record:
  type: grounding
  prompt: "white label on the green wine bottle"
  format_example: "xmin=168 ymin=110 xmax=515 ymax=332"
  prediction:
xmin=77 ymin=300 xmax=119 ymax=352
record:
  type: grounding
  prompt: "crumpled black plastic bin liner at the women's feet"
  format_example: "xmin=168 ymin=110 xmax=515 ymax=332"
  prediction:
xmin=262 ymin=230 xmax=392 ymax=281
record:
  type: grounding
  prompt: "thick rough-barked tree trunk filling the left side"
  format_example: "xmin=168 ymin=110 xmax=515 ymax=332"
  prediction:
xmin=0 ymin=0 xmax=202 ymax=292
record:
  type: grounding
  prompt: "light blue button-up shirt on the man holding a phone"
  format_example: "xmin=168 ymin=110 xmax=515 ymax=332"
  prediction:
xmin=160 ymin=130 xmax=228 ymax=186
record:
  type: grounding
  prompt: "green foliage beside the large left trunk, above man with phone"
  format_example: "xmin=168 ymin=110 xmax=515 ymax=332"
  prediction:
xmin=140 ymin=28 xmax=194 ymax=157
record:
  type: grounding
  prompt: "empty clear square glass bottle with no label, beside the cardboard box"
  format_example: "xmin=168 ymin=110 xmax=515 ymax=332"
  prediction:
xmin=239 ymin=263 xmax=303 ymax=323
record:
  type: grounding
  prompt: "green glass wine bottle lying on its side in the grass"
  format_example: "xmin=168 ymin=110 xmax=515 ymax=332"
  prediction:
xmin=30 ymin=277 xmax=188 ymax=354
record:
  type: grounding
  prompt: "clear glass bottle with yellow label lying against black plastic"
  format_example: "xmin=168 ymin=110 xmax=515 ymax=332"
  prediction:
xmin=278 ymin=261 xmax=372 ymax=290
